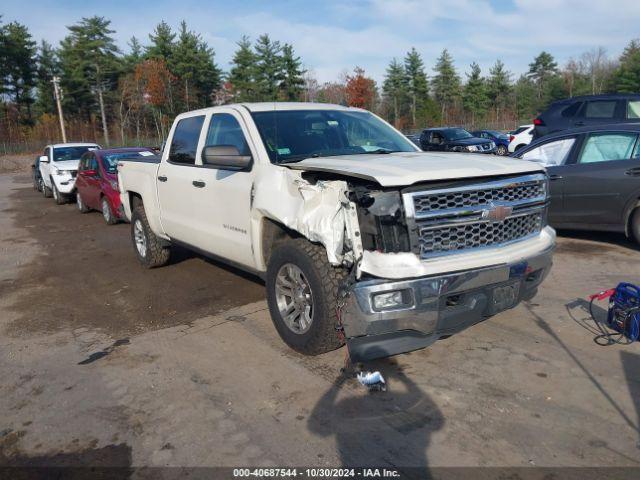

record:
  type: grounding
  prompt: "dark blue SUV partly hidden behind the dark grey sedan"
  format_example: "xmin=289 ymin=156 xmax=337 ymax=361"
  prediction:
xmin=533 ymin=94 xmax=640 ymax=140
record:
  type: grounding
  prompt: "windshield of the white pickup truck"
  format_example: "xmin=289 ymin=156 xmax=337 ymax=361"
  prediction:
xmin=252 ymin=110 xmax=416 ymax=163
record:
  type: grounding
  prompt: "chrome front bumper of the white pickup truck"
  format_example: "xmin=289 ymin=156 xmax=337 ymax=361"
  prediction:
xmin=342 ymin=247 xmax=553 ymax=361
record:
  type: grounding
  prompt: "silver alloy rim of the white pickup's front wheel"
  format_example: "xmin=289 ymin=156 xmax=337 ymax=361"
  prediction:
xmin=276 ymin=263 xmax=313 ymax=334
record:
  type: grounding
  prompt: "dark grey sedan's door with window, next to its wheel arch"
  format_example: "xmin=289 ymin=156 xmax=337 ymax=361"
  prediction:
xmin=564 ymin=132 xmax=640 ymax=227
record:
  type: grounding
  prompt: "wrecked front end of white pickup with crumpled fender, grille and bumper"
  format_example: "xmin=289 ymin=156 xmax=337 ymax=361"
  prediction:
xmin=252 ymin=164 xmax=555 ymax=361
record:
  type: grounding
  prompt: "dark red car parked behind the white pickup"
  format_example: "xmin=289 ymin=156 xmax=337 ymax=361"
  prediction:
xmin=76 ymin=147 xmax=154 ymax=225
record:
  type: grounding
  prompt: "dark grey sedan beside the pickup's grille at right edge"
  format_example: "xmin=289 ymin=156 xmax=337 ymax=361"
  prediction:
xmin=512 ymin=124 xmax=640 ymax=242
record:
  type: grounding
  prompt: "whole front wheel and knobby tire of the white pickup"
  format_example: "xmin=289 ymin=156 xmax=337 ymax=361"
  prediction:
xmin=266 ymin=238 xmax=347 ymax=355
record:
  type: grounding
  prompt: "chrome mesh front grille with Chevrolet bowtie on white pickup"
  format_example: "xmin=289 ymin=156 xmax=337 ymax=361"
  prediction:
xmin=403 ymin=173 xmax=547 ymax=258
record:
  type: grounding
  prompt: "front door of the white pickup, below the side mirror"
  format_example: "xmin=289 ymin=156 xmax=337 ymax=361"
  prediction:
xmin=192 ymin=108 xmax=256 ymax=268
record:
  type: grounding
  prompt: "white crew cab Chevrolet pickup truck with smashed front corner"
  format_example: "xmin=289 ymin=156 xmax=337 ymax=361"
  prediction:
xmin=118 ymin=103 xmax=555 ymax=360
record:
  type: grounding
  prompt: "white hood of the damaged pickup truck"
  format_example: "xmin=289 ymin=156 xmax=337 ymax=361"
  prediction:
xmin=285 ymin=152 xmax=544 ymax=187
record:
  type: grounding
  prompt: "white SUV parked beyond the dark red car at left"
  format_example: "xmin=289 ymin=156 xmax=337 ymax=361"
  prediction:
xmin=40 ymin=143 xmax=100 ymax=205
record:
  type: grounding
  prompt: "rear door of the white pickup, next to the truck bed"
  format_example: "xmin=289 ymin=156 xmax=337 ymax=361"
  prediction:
xmin=155 ymin=115 xmax=205 ymax=242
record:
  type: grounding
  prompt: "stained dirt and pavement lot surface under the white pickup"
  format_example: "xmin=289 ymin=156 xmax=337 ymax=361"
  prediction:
xmin=0 ymin=175 xmax=640 ymax=478
